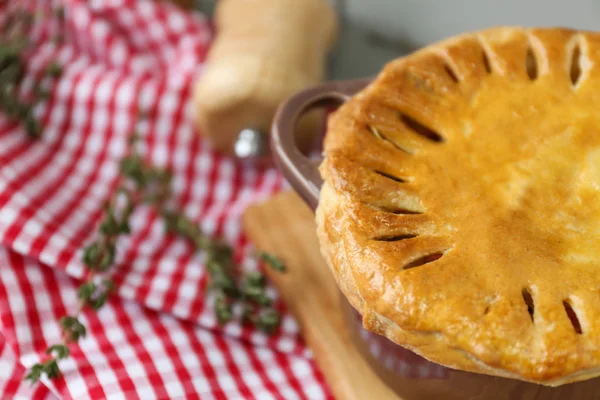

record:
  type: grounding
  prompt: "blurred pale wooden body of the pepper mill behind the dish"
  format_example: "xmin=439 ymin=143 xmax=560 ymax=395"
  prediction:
xmin=194 ymin=0 xmax=337 ymax=153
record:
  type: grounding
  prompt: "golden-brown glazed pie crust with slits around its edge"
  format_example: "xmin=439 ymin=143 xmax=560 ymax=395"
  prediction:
xmin=317 ymin=27 xmax=600 ymax=386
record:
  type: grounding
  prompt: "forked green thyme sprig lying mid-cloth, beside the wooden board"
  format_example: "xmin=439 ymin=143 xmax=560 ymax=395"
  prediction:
xmin=25 ymin=118 xmax=285 ymax=384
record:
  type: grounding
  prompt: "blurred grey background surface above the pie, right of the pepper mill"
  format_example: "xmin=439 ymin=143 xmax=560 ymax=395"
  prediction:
xmin=198 ymin=0 xmax=600 ymax=79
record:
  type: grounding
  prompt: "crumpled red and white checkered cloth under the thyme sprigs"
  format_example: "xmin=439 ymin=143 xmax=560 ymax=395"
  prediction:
xmin=0 ymin=0 xmax=331 ymax=399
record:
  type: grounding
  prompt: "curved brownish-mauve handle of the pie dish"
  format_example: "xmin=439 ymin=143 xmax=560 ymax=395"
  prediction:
xmin=271 ymin=79 xmax=370 ymax=210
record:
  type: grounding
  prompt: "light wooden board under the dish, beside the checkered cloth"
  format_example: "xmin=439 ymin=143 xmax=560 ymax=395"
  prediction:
xmin=243 ymin=192 xmax=399 ymax=400
